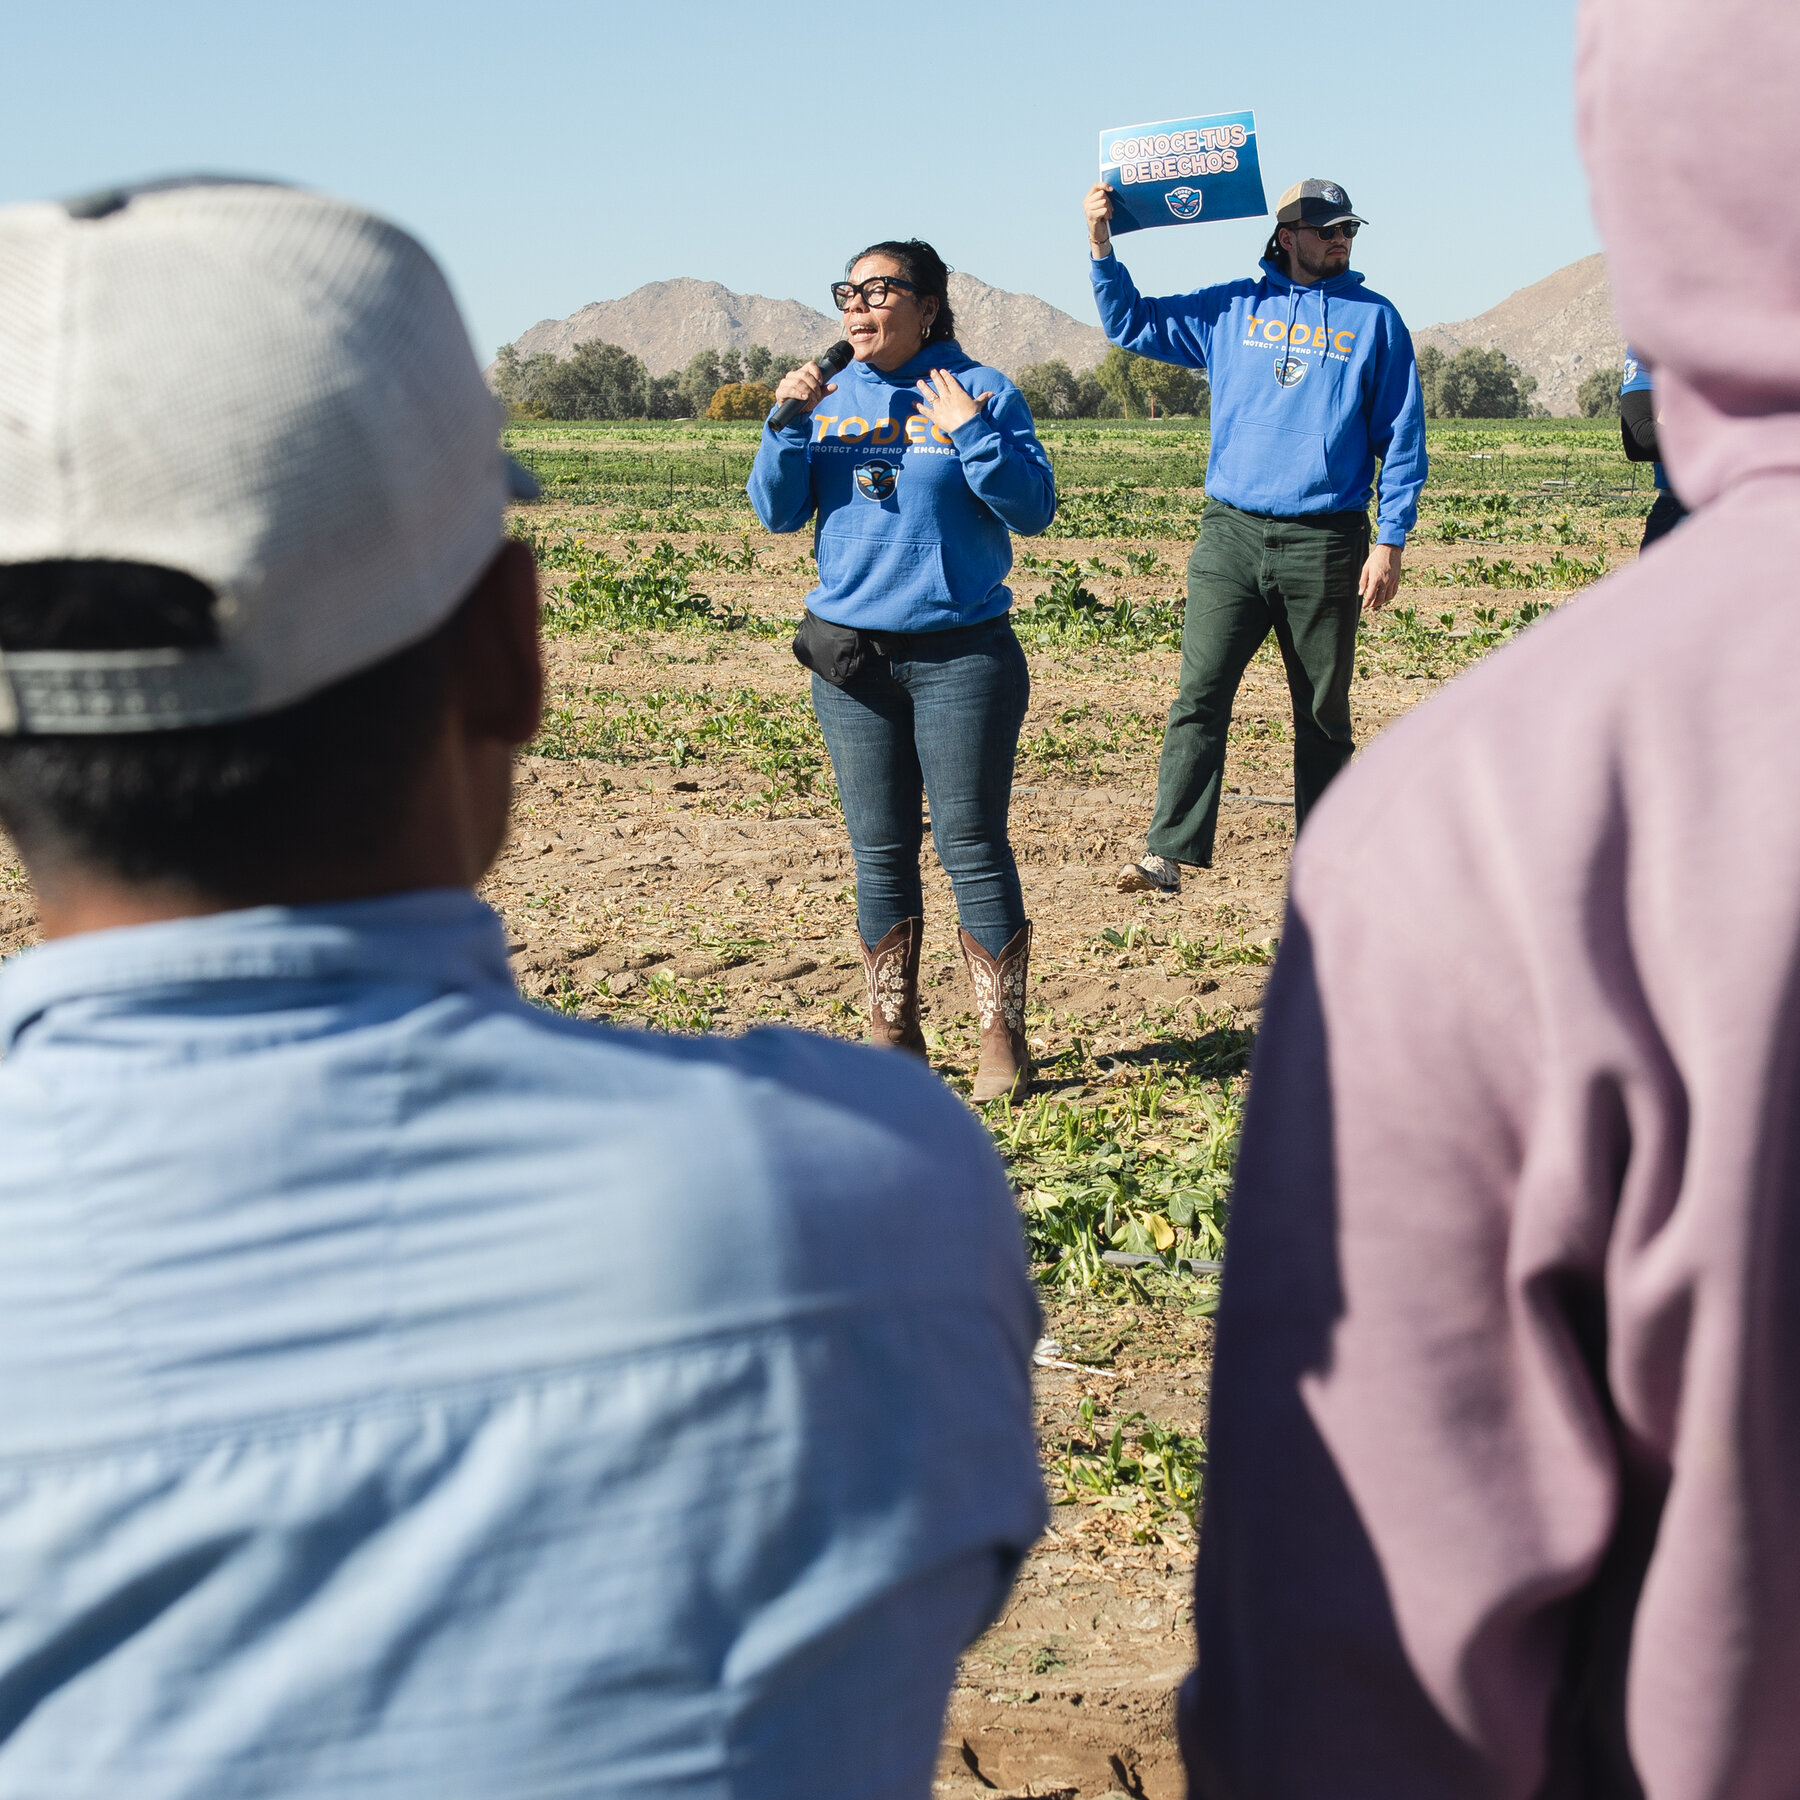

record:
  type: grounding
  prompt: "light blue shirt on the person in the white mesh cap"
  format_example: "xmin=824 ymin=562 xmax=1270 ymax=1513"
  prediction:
xmin=0 ymin=893 xmax=1044 ymax=1800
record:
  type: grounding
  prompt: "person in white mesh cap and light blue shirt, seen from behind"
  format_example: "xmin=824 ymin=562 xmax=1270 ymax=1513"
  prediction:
xmin=0 ymin=171 xmax=1044 ymax=1800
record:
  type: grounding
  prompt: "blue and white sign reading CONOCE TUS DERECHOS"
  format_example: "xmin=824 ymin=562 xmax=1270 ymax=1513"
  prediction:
xmin=1100 ymin=112 xmax=1269 ymax=236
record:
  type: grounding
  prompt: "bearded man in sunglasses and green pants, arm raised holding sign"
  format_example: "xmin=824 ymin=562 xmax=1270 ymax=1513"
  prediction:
xmin=1085 ymin=180 xmax=1426 ymax=895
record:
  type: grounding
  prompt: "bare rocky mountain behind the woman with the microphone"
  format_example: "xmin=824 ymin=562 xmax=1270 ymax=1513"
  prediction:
xmin=496 ymin=274 xmax=1107 ymax=374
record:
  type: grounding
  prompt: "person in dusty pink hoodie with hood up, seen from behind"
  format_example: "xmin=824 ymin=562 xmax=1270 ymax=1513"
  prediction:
xmin=1181 ymin=0 xmax=1800 ymax=1800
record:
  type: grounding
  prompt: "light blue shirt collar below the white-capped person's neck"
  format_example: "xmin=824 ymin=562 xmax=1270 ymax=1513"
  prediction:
xmin=0 ymin=887 xmax=513 ymax=1055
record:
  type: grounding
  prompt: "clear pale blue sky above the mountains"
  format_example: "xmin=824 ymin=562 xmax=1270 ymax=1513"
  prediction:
xmin=0 ymin=0 xmax=1598 ymax=356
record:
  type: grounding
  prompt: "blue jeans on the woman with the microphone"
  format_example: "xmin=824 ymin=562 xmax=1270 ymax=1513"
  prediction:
xmin=812 ymin=616 xmax=1031 ymax=956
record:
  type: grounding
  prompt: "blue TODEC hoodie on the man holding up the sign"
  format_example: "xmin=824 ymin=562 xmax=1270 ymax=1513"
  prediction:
xmin=1089 ymin=256 xmax=1426 ymax=544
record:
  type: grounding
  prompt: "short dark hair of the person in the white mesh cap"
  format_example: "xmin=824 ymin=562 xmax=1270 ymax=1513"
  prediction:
xmin=0 ymin=562 xmax=463 ymax=898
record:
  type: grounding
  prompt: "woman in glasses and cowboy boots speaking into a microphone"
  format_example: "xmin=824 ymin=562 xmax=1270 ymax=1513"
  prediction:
xmin=749 ymin=238 xmax=1057 ymax=1100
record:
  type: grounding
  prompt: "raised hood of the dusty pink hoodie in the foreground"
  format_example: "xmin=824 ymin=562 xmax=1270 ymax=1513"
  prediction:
xmin=1577 ymin=0 xmax=1800 ymax=506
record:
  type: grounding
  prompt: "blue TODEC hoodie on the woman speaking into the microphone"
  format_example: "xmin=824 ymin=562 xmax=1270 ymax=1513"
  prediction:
xmin=749 ymin=342 xmax=1057 ymax=632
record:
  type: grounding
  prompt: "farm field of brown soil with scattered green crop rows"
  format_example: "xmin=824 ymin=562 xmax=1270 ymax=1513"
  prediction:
xmin=0 ymin=419 xmax=1652 ymax=1800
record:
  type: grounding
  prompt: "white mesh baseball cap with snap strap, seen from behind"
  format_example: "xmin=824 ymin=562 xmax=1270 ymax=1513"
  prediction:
xmin=0 ymin=176 xmax=529 ymax=734
